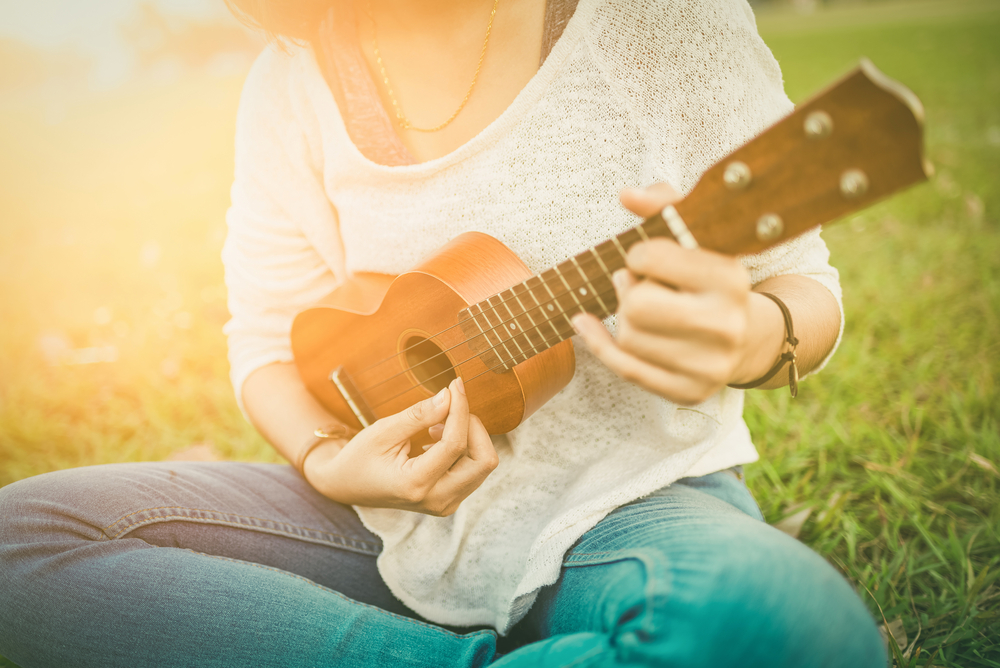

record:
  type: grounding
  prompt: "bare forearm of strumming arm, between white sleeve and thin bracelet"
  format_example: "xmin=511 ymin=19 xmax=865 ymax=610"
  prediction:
xmin=243 ymin=363 xmax=352 ymax=463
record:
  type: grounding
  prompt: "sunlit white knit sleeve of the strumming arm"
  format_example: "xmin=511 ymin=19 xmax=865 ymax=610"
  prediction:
xmin=222 ymin=47 xmax=343 ymax=410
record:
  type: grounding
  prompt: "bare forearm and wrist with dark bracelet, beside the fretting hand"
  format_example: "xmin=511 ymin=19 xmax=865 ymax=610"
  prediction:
xmin=731 ymin=275 xmax=840 ymax=389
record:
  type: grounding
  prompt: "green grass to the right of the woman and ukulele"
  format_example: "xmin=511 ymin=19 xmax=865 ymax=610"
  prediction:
xmin=747 ymin=3 xmax=1000 ymax=667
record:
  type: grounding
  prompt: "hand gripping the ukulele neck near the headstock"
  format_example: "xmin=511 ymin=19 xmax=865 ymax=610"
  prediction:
xmin=573 ymin=184 xmax=783 ymax=405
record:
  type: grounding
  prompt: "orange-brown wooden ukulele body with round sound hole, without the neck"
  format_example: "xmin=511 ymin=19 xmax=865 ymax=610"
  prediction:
xmin=292 ymin=232 xmax=575 ymax=434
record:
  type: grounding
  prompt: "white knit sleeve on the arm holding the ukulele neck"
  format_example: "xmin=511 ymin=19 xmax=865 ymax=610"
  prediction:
xmin=590 ymin=0 xmax=844 ymax=373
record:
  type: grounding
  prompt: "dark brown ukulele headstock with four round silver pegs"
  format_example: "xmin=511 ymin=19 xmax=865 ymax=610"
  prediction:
xmin=676 ymin=59 xmax=932 ymax=255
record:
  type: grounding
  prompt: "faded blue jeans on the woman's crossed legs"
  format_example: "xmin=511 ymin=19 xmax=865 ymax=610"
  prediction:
xmin=0 ymin=462 xmax=887 ymax=668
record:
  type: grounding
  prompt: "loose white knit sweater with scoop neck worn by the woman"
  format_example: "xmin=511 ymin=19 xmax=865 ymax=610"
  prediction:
xmin=223 ymin=0 xmax=840 ymax=632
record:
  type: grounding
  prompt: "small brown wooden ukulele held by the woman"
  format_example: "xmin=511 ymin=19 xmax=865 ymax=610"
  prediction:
xmin=291 ymin=60 xmax=931 ymax=438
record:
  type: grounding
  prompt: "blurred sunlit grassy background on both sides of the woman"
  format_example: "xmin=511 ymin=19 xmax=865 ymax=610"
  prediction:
xmin=0 ymin=0 xmax=1000 ymax=668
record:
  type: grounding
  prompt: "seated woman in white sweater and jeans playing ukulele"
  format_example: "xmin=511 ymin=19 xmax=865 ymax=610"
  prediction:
xmin=0 ymin=0 xmax=886 ymax=668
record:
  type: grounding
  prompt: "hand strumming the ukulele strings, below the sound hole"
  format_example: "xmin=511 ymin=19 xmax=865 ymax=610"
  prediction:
xmin=303 ymin=378 xmax=499 ymax=517
